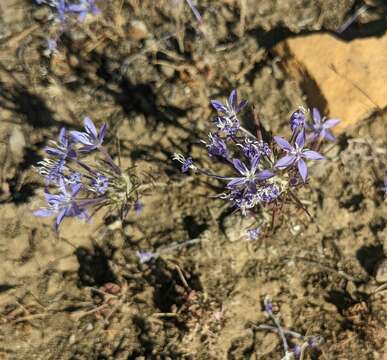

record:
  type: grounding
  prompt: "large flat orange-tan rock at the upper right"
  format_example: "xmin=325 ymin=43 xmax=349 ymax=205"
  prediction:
xmin=275 ymin=34 xmax=387 ymax=132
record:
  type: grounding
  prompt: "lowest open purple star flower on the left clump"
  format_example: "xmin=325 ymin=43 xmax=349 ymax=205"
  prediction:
xmin=34 ymin=178 xmax=87 ymax=231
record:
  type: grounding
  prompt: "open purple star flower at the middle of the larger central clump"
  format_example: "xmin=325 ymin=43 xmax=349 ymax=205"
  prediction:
xmin=227 ymin=155 xmax=274 ymax=189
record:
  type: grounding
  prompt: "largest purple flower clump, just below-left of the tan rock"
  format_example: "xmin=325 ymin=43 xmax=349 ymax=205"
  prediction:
xmin=174 ymin=90 xmax=339 ymax=232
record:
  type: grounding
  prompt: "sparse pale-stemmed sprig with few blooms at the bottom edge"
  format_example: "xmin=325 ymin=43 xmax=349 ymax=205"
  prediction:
xmin=254 ymin=296 xmax=323 ymax=360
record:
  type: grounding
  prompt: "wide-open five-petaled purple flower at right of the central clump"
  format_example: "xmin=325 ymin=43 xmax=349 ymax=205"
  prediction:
xmin=274 ymin=131 xmax=325 ymax=182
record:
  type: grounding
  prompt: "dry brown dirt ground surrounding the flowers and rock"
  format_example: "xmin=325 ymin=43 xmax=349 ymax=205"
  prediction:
xmin=0 ymin=0 xmax=387 ymax=360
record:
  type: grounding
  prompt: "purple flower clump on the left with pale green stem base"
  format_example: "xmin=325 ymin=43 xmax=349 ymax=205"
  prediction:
xmin=34 ymin=118 xmax=147 ymax=231
